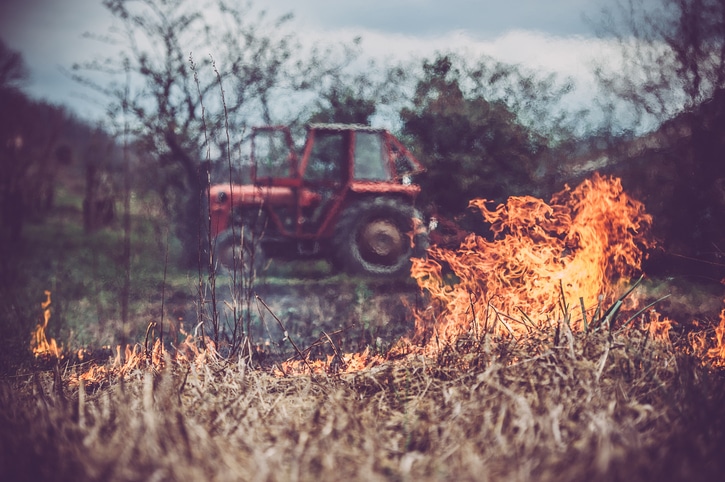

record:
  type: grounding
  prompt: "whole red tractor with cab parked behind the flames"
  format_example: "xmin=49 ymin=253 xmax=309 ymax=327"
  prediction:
xmin=209 ymin=124 xmax=428 ymax=276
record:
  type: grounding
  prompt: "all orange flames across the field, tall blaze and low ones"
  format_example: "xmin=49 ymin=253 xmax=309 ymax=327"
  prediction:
xmin=24 ymin=175 xmax=725 ymax=380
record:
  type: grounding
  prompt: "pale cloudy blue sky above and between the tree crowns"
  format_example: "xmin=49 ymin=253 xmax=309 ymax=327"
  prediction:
xmin=0 ymin=0 xmax=607 ymax=117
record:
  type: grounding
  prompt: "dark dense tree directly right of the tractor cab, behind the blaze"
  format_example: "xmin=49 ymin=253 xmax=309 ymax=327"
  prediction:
xmin=401 ymin=54 xmax=570 ymax=221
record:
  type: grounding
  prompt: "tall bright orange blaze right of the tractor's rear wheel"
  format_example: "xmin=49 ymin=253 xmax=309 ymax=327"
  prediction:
xmin=412 ymin=175 xmax=653 ymax=341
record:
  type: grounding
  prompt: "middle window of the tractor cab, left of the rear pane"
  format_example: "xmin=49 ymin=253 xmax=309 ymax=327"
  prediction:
xmin=305 ymin=131 xmax=347 ymax=183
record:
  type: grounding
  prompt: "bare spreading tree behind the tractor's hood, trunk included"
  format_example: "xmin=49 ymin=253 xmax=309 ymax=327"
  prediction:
xmin=73 ymin=0 xmax=364 ymax=262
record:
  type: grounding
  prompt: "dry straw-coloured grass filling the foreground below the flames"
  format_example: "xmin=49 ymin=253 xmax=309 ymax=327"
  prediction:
xmin=0 ymin=330 xmax=725 ymax=481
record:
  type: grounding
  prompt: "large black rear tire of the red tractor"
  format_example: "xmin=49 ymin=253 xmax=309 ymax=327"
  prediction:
xmin=333 ymin=198 xmax=428 ymax=277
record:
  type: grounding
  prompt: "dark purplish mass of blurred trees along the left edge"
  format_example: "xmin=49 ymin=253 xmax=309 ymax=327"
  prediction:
xmin=0 ymin=40 xmax=118 ymax=244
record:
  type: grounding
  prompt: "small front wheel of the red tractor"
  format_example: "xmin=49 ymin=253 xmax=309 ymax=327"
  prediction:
xmin=213 ymin=226 xmax=264 ymax=276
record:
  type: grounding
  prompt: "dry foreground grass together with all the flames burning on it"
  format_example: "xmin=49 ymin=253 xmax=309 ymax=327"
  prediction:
xmin=0 ymin=177 xmax=725 ymax=481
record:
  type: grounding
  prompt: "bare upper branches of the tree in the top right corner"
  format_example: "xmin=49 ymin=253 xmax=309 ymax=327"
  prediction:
xmin=596 ymin=0 xmax=725 ymax=125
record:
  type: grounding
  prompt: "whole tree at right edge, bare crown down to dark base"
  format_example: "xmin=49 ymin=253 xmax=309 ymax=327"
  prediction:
xmin=597 ymin=0 xmax=725 ymax=259
